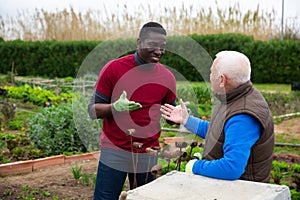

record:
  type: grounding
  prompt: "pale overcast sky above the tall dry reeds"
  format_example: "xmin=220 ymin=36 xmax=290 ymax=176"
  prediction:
xmin=0 ymin=0 xmax=300 ymax=28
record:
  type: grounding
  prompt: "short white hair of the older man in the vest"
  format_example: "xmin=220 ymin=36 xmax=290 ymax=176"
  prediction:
xmin=215 ymin=51 xmax=251 ymax=84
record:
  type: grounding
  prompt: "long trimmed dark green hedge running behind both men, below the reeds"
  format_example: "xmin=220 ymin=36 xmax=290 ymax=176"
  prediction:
xmin=0 ymin=34 xmax=300 ymax=84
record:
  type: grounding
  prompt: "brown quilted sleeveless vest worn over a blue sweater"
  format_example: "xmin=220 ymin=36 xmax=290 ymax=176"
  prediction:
xmin=203 ymin=81 xmax=274 ymax=183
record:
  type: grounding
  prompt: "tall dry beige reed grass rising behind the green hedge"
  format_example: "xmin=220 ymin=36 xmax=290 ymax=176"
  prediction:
xmin=0 ymin=3 xmax=299 ymax=41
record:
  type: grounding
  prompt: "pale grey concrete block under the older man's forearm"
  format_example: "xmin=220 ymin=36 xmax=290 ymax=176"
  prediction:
xmin=127 ymin=171 xmax=291 ymax=200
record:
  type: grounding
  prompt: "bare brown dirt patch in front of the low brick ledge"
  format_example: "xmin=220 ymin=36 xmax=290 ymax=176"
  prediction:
xmin=0 ymin=160 xmax=98 ymax=200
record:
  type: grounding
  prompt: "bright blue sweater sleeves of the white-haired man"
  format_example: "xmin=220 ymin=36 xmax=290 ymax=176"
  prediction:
xmin=185 ymin=114 xmax=261 ymax=180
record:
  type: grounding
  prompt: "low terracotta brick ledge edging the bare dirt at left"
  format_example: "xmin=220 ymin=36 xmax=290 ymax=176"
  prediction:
xmin=0 ymin=151 xmax=100 ymax=176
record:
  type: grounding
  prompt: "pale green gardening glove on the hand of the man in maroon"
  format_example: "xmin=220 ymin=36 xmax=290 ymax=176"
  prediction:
xmin=113 ymin=91 xmax=142 ymax=112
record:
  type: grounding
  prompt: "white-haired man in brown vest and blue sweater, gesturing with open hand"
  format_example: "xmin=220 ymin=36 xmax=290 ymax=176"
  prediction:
xmin=161 ymin=51 xmax=274 ymax=183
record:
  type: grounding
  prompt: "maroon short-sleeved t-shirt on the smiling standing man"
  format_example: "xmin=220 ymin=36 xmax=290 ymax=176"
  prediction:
xmin=95 ymin=54 xmax=176 ymax=152
